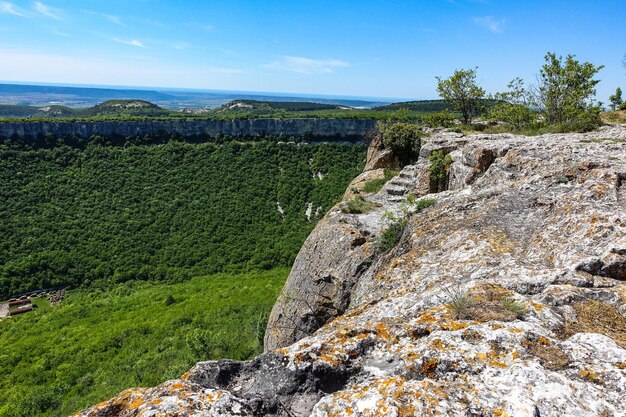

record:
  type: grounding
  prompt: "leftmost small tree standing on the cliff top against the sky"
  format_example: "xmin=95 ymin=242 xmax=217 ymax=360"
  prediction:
xmin=436 ymin=68 xmax=485 ymax=124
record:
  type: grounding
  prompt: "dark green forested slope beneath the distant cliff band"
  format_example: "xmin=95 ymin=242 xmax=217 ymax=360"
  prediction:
xmin=0 ymin=141 xmax=366 ymax=298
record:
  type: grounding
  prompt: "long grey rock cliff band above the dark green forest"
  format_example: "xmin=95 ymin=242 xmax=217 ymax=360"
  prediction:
xmin=0 ymin=118 xmax=376 ymax=139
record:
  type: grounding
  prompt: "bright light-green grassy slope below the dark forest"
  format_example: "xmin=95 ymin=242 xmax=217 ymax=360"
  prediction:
xmin=0 ymin=268 xmax=289 ymax=417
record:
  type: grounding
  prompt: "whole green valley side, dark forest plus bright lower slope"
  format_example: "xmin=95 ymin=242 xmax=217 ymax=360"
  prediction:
xmin=0 ymin=136 xmax=366 ymax=417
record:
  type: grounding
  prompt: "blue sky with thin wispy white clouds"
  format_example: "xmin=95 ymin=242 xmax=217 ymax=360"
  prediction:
xmin=0 ymin=0 xmax=626 ymax=102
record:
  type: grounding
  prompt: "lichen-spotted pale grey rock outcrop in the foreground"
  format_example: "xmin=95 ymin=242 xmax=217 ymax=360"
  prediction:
xmin=79 ymin=127 xmax=626 ymax=417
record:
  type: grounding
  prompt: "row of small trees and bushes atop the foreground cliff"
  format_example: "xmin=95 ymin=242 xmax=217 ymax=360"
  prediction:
xmin=437 ymin=52 xmax=624 ymax=131
